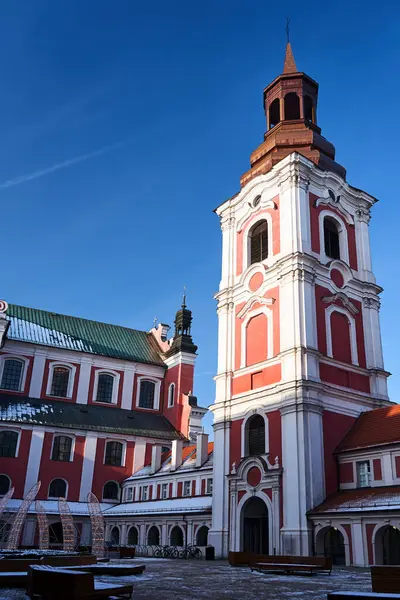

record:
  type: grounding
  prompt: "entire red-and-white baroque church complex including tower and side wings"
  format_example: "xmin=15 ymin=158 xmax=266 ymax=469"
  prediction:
xmin=0 ymin=44 xmax=400 ymax=566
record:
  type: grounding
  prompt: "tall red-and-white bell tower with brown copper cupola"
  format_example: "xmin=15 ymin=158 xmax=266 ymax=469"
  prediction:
xmin=209 ymin=43 xmax=389 ymax=556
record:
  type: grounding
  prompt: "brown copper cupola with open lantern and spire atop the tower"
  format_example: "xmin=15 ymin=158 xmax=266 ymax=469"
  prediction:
xmin=240 ymin=42 xmax=346 ymax=187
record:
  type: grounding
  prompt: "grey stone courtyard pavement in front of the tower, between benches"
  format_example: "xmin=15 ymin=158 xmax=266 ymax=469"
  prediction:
xmin=0 ymin=558 xmax=371 ymax=600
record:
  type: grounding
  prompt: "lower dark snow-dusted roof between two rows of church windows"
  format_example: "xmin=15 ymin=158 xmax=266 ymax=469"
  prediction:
xmin=0 ymin=393 xmax=185 ymax=440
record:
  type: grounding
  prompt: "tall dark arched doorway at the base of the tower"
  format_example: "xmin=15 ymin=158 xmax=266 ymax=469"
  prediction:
xmin=242 ymin=497 xmax=269 ymax=554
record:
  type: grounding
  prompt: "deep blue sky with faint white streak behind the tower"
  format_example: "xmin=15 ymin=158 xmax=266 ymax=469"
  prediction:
xmin=0 ymin=0 xmax=400 ymax=434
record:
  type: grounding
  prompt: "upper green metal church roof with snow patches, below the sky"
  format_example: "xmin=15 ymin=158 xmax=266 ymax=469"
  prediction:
xmin=7 ymin=304 xmax=164 ymax=366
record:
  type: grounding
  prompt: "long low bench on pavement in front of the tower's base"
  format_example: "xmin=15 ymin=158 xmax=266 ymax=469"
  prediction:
xmin=250 ymin=555 xmax=332 ymax=575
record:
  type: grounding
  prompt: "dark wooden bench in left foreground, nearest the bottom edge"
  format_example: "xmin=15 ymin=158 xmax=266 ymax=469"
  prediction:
xmin=26 ymin=565 xmax=133 ymax=600
